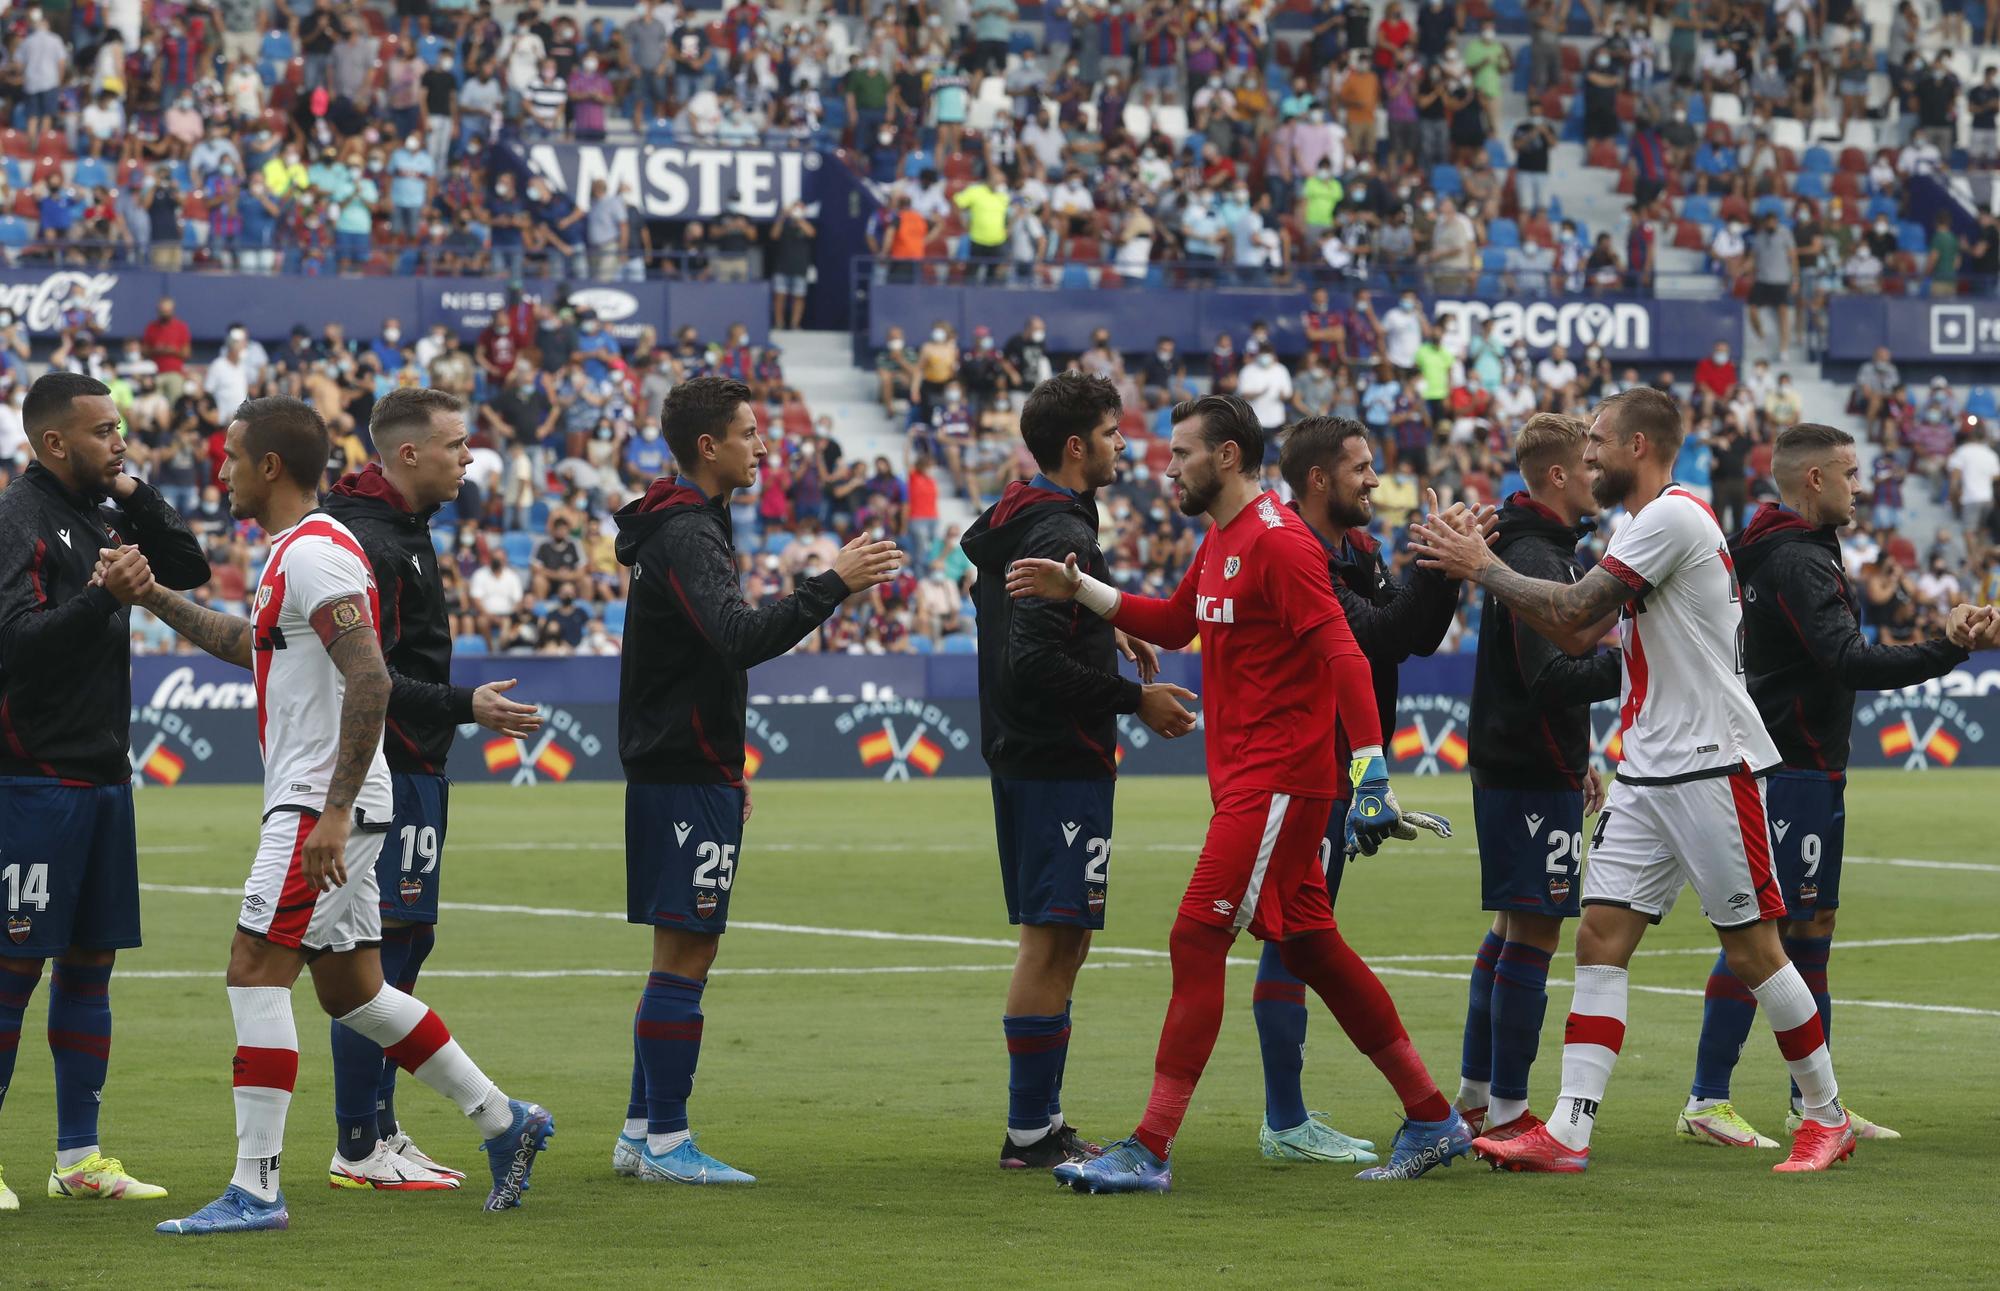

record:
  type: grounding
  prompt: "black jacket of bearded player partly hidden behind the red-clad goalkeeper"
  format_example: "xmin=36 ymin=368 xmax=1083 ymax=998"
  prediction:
xmin=1290 ymin=502 xmax=1458 ymax=801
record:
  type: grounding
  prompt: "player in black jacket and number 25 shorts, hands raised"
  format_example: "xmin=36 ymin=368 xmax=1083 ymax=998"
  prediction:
xmin=612 ymin=376 xmax=902 ymax=1183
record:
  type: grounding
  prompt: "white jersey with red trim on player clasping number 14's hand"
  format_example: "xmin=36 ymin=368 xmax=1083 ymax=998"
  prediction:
xmin=250 ymin=512 xmax=396 ymax=827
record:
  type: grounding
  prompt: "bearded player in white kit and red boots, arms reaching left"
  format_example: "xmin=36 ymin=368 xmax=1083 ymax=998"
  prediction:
xmin=1414 ymin=386 xmax=1854 ymax=1173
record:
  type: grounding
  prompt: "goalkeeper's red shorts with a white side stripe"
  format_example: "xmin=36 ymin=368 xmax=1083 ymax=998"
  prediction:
xmin=1180 ymin=789 xmax=1334 ymax=941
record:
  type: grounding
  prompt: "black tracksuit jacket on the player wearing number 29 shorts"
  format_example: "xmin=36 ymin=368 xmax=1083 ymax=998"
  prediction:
xmin=1468 ymin=494 xmax=1618 ymax=789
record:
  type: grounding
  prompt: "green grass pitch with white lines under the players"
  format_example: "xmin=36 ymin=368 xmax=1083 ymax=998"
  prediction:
xmin=0 ymin=771 xmax=2000 ymax=1291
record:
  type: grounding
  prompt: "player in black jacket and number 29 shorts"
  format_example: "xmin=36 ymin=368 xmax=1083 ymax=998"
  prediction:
xmin=1458 ymin=412 xmax=1618 ymax=1141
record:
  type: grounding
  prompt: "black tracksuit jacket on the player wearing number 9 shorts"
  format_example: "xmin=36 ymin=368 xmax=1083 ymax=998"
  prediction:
xmin=1730 ymin=504 xmax=1970 ymax=773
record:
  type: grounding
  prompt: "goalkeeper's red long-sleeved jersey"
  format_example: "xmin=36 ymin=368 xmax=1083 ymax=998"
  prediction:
xmin=1112 ymin=494 xmax=1382 ymax=799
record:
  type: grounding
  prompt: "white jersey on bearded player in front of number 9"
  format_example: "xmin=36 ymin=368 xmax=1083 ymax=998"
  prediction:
xmin=1602 ymin=484 xmax=1778 ymax=783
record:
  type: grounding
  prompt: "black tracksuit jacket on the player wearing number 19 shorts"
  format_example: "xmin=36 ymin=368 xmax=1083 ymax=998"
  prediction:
xmin=322 ymin=462 xmax=472 ymax=775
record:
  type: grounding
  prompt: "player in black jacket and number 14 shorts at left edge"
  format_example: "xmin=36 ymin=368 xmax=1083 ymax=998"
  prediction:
xmin=0 ymin=372 xmax=208 ymax=1211
